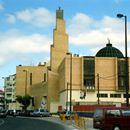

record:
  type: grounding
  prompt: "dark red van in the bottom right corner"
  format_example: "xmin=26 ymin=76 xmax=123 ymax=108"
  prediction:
xmin=93 ymin=108 xmax=130 ymax=130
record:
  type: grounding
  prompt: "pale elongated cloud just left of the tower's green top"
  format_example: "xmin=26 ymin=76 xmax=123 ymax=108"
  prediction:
xmin=16 ymin=8 xmax=55 ymax=27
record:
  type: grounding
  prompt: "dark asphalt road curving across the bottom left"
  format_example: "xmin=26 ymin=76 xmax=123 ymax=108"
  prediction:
xmin=0 ymin=117 xmax=76 ymax=130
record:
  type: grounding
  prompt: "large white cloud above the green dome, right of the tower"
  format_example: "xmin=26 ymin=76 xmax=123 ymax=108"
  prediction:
xmin=68 ymin=13 xmax=130 ymax=54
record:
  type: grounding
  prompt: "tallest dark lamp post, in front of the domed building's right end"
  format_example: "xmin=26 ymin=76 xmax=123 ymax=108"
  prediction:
xmin=117 ymin=14 xmax=129 ymax=107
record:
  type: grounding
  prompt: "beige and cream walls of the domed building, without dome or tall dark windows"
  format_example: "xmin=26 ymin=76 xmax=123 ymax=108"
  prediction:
xmin=59 ymin=56 xmax=130 ymax=108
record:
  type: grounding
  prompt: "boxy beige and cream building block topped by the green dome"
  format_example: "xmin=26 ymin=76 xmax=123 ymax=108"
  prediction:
xmin=59 ymin=43 xmax=130 ymax=108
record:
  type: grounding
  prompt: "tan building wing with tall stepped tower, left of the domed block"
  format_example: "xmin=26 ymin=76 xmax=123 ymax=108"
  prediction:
xmin=16 ymin=8 xmax=68 ymax=111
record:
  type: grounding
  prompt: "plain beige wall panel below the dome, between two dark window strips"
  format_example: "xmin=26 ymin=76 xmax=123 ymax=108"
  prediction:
xmin=95 ymin=57 xmax=117 ymax=91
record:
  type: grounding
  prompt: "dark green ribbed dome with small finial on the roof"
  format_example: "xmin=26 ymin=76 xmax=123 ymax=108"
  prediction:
xmin=96 ymin=43 xmax=124 ymax=58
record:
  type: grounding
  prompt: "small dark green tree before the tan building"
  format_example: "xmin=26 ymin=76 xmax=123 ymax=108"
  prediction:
xmin=16 ymin=95 xmax=32 ymax=110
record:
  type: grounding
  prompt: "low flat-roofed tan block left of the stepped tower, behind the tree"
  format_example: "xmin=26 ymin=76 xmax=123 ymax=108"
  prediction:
xmin=16 ymin=63 xmax=47 ymax=109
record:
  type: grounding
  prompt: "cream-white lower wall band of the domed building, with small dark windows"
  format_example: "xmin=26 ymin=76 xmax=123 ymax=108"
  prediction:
xmin=60 ymin=90 xmax=126 ymax=109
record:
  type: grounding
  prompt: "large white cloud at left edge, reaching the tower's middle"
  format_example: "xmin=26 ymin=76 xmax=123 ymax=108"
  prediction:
xmin=0 ymin=30 xmax=52 ymax=66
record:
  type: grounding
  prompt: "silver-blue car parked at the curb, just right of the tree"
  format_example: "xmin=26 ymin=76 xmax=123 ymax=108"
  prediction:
xmin=30 ymin=108 xmax=51 ymax=117
